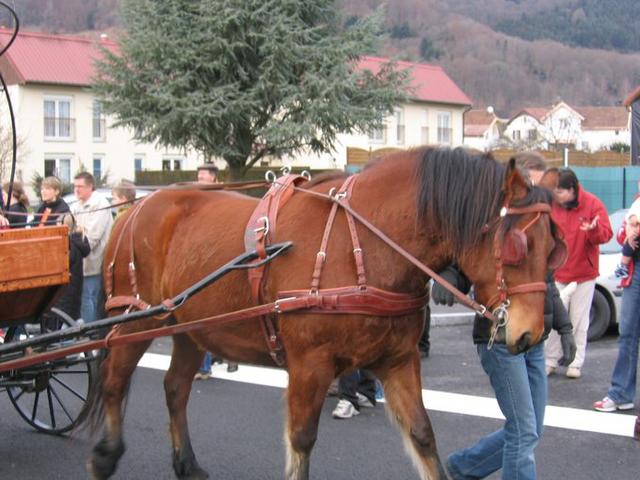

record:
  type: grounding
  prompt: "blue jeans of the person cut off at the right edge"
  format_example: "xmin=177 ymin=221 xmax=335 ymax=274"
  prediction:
xmin=607 ymin=261 xmax=640 ymax=403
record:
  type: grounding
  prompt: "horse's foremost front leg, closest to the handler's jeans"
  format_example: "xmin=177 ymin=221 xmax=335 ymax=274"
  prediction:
xmin=375 ymin=350 xmax=446 ymax=480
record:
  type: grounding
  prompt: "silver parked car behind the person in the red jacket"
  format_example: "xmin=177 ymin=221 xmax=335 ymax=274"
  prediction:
xmin=587 ymin=209 xmax=627 ymax=341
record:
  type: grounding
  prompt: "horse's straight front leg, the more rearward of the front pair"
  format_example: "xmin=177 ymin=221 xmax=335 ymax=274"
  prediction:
xmin=284 ymin=355 xmax=334 ymax=480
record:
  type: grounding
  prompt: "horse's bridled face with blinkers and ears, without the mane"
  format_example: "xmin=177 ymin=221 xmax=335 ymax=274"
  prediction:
xmin=465 ymin=160 xmax=566 ymax=353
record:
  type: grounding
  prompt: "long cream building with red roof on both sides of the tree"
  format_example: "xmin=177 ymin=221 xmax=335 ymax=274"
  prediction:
xmin=0 ymin=29 xmax=471 ymax=193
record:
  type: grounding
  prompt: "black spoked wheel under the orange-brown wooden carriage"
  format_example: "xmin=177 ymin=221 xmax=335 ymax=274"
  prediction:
xmin=5 ymin=322 xmax=96 ymax=435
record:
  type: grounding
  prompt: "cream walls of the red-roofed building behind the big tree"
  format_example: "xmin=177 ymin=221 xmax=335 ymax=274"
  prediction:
xmin=2 ymin=81 xmax=464 ymax=192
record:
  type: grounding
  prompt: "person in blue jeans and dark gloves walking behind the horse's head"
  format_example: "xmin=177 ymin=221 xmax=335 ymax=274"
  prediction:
xmin=431 ymin=266 xmax=576 ymax=480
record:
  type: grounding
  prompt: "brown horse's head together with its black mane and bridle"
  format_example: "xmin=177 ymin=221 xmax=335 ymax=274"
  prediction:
xmin=419 ymin=149 xmax=566 ymax=353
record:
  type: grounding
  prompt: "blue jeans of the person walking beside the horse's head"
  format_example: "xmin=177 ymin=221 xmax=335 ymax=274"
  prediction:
xmin=447 ymin=343 xmax=547 ymax=480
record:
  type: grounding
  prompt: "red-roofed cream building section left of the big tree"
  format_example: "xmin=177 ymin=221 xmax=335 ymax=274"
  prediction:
xmin=0 ymin=29 xmax=210 ymax=197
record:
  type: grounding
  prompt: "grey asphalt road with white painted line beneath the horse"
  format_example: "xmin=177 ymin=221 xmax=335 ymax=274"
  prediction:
xmin=0 ymin=325 xmax=640 ymax=480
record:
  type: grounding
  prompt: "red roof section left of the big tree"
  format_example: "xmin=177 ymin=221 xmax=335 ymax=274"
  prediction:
xmin=0 ymin=28 xmax=117 ymax=86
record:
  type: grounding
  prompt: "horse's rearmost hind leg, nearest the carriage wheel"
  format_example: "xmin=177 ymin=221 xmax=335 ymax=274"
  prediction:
xmin=87 ymin=341 xmax=151 ymax=479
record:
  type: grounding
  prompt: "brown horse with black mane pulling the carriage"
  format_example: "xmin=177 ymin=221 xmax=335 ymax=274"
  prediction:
xmin=88 ymin=148 xmax=555 ymax=480
